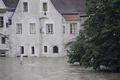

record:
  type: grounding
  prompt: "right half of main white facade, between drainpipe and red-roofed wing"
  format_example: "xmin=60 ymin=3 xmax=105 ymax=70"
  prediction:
xmin=40 ymin=0 xmax=65 ymax=57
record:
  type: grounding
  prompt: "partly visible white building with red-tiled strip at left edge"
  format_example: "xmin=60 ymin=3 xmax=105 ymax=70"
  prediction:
xmin=0 ymin=0 xmax=17 ymax=56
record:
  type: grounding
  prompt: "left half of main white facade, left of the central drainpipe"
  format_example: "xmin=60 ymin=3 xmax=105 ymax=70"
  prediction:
xmin=10 ymin=0 xmax=40 ymax=56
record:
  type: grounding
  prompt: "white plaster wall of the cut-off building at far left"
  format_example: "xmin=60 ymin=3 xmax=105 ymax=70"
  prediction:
xmin=0 ymin=0 xmax=12 ymax=55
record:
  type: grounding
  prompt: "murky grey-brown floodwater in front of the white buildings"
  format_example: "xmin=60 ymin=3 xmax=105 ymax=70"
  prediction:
xmin=0 ymin=58 xmax=120 ymax=80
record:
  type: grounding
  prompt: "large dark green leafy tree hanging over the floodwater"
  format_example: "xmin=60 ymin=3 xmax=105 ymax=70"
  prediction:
xmin=68 ymin=0 xmax=120 ymax=70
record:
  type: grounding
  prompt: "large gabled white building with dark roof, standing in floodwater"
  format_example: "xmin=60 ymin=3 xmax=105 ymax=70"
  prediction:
xmin=0 ymin=0 xmax=85 ymax=57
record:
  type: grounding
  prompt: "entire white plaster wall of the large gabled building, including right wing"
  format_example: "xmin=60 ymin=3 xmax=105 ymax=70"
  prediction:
xmin=10 ymin=0 xmax=85 ymax=57
